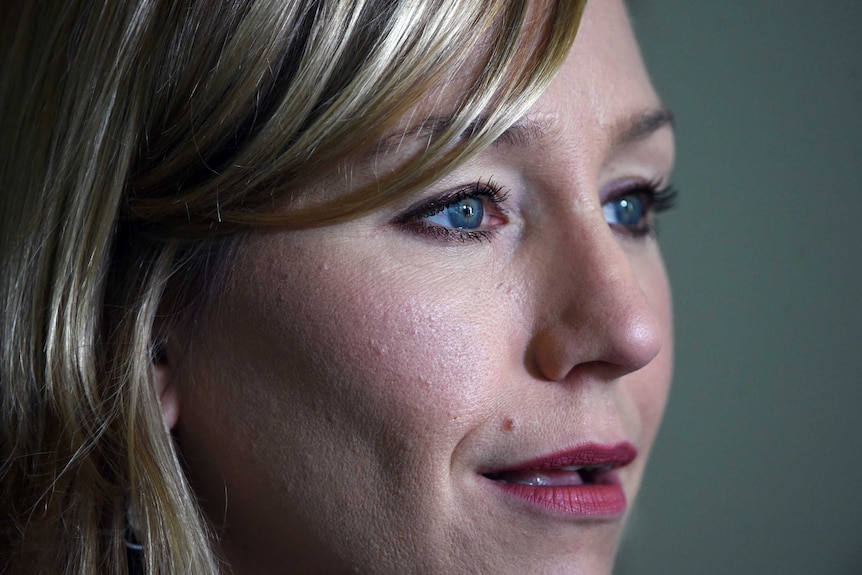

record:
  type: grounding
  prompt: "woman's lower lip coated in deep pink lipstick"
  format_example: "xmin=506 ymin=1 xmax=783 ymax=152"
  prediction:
xmin=486 ymin=478 xmax=627 ymax=519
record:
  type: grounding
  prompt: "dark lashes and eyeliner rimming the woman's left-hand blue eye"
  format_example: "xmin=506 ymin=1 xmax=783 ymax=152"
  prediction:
xmin=395 ymin=180 xmax=508 ymax=242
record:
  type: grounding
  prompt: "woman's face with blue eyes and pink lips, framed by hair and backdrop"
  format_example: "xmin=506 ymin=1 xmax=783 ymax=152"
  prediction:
xmin=164 ymin=0 xmax=673 ymax=573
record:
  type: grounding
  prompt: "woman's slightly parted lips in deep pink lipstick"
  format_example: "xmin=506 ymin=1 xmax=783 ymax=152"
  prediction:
xmin=483 ymin=442 xmax=637 ymax=518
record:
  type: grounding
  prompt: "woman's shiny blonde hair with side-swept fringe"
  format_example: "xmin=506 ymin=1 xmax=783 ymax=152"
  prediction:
xmin=0 ymin=0 xmax=583 ymax=573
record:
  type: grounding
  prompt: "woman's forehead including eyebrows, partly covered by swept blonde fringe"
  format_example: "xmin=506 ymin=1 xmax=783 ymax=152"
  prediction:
xmin=367 ymin=0 xmax=671 ymax=164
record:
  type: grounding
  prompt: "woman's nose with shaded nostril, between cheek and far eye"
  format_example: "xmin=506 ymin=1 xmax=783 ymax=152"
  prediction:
xmin=529 ymin=214 xmax=664 ymax=381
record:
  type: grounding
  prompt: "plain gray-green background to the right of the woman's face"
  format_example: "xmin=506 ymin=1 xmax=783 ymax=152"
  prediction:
xmin=616 ymin=0 xmax=862 ymax=575
